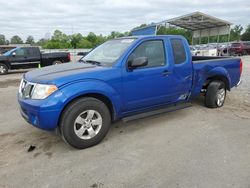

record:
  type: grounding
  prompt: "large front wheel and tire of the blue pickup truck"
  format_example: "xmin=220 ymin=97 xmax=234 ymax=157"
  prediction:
xmin=59 ymin=97 xmax=111 ymax=149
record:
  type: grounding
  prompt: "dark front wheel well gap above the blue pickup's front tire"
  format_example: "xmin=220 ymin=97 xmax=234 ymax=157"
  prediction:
xmin=58 ymin=93 xmax=115 ymax=122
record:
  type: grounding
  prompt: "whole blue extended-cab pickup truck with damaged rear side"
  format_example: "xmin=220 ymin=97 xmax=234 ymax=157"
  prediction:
xmin=18 ymin=35 xmax=242 ymax=149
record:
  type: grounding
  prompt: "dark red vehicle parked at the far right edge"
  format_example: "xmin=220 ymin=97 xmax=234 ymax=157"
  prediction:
xmin=228 ymin=42 xmax=250 ymax=55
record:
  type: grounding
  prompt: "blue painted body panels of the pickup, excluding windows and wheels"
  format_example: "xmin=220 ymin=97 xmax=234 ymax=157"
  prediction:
xmin=18 ymin=36 xmax=240 ymax=130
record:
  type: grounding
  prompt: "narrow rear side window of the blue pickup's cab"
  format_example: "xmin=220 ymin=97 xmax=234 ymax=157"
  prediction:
xmin=171 ymin=39 xmax=186 ymax=64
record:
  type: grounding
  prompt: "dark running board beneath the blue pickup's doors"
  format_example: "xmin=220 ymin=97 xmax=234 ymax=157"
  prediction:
xmin=122 ymin=103 xmax=192 ymax=123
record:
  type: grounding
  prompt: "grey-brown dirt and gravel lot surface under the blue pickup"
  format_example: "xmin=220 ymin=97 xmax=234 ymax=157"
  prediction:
xmin=0 ymin=56 xmax=250 ymax=188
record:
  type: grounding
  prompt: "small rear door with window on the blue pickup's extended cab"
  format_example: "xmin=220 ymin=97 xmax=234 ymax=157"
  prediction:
xmin=170 ymin=37 xmax=193 ymax=101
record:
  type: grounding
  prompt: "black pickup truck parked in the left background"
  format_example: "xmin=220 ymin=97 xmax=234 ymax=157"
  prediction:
xmin=0 ymin=47 xmax=70 ymax=75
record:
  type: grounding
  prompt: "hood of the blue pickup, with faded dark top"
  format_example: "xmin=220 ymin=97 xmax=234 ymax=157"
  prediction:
xmin=24 ymin=63 xmax=108 ymax=87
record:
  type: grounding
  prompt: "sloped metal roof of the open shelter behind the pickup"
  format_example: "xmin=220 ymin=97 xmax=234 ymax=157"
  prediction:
xmin=160 ymin=12 xmax=232 ymax=31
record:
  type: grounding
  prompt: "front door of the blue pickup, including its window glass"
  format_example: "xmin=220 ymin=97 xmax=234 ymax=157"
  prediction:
xmin=123 ymin=39 xmax=174 ymax=113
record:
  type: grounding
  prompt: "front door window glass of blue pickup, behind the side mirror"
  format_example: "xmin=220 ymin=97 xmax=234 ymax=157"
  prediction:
xmin=129 ymin=40 xmax=165 ymax=68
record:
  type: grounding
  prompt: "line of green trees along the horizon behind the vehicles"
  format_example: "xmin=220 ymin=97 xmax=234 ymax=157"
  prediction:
xmin=0 ymin=24 xmax=250 ymax=49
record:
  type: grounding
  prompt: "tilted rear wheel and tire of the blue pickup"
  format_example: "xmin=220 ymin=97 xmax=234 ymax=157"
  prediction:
xmin=205 ymin=81 xmax=226 ymax=108
